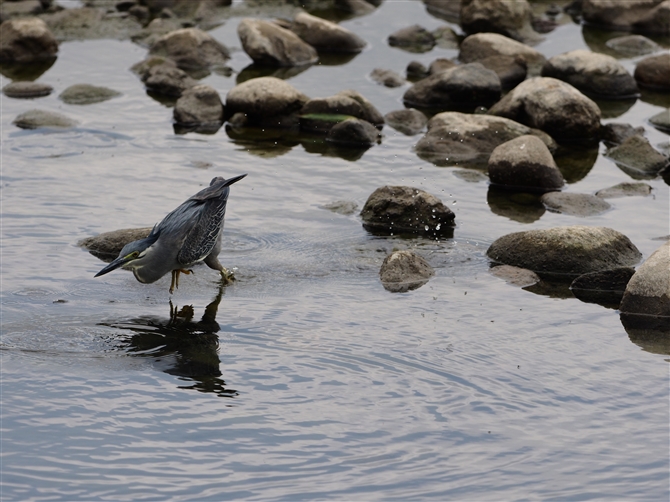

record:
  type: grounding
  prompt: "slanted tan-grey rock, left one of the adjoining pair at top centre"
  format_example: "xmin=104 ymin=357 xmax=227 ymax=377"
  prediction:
xmin=237 ymin=18 xmax=319 ymax=66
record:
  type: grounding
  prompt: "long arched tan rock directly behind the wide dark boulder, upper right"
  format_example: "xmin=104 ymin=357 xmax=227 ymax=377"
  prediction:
xmin=458 ymin=33 xmax=546 ymax=75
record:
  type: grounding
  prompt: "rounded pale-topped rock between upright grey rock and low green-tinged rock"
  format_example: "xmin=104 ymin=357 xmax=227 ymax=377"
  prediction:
xmin=226 ymin=77 xmax=309 ymax=127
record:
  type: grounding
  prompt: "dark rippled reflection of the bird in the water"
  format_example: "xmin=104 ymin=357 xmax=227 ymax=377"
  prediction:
xmin=100 ymin=287 xmax=238 ymax=397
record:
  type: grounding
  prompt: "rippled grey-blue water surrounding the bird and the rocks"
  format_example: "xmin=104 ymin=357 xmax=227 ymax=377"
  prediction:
xmin=0 ymin=1 xmax=670 ymax=501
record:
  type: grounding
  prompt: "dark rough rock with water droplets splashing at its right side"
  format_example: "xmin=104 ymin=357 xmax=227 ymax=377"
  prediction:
xmin=361 ymin=186 xmax=455 ymax=237
